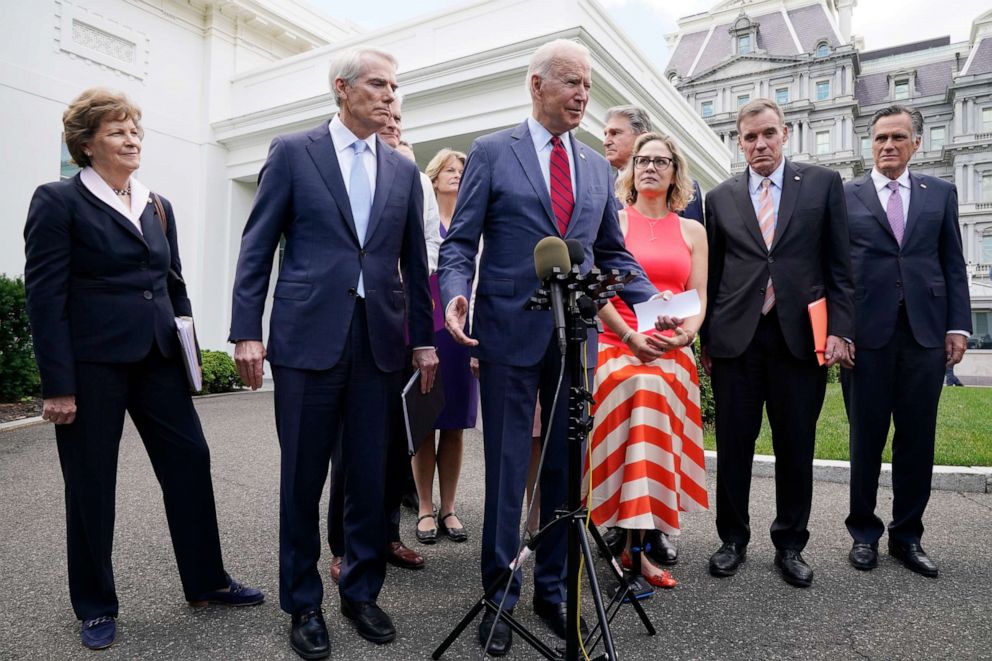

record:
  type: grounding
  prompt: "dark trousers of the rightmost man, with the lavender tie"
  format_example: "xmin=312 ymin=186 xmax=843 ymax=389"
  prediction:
xmin=841 ymin=307 xmax=945 ymax=544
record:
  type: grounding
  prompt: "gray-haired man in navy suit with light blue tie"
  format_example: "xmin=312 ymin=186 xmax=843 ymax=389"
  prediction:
xmin=230 ymin=48 xmax=438 ymax=659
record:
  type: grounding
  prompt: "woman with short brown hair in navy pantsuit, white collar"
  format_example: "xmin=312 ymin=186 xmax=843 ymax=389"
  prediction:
xmin=24 ymin=89 xmax=264 ymax=649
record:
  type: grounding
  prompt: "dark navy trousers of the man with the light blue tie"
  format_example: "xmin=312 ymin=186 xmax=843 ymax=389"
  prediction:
xmin=272 ymin=302 xmax=401 ymax=613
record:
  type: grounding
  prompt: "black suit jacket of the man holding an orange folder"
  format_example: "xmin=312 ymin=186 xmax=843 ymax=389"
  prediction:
xmin=701 ymin=159 xmax=854 ymax=358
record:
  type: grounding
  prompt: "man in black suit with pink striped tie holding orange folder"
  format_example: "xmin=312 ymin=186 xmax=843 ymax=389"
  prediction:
xmin=700 ymin=99 xmax=854 ymax=587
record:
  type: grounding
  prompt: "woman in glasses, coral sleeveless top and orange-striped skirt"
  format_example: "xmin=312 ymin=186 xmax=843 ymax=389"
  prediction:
xmin=584 ymin=133 xmax=708 ymax=587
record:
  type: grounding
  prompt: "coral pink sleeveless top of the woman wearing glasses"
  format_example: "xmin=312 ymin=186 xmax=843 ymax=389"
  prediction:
xmin=599 ymin=206 xmax=692 ymax=346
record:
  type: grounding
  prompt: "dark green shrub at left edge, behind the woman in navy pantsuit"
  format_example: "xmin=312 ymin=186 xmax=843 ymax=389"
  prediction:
xmin=0 ymin=274 xmax=41 ymax=402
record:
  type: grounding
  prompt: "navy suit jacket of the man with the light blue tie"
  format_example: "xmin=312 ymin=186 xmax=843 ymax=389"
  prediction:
xmin=230 ymin=122 xmax=434 ymax=372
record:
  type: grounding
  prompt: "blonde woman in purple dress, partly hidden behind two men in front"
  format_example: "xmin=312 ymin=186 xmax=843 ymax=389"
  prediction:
xmin=413 ymin=149 xmax=479 ymax=544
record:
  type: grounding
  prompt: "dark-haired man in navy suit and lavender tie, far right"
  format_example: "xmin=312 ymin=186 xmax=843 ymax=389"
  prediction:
xmin=842 ymin=105 xmax=971 ymax=577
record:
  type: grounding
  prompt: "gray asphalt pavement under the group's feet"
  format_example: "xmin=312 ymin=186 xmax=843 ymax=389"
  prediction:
xmin=0 ymin=393 xmax=992 ymax=661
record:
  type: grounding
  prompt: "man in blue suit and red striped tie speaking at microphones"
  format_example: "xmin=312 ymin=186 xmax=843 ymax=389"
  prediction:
xmin=438 ymin=40 xmax=656 ymax=656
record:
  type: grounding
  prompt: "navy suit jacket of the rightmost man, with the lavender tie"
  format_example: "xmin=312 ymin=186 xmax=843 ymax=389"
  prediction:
xmin=844 ymin=172 xmax=971 ymax=349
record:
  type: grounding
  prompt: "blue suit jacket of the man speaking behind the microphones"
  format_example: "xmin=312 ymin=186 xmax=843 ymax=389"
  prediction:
xmin=438 ymin=121 xmax=656 ymax=367
